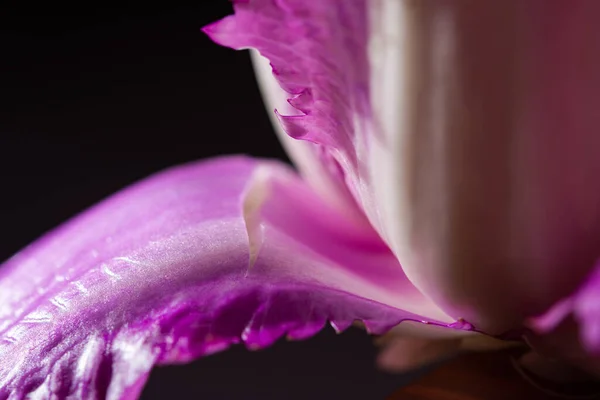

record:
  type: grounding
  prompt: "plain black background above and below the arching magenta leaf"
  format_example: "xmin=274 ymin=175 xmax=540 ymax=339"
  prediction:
xmin=0 ymin=0 xmax=418 ymax=400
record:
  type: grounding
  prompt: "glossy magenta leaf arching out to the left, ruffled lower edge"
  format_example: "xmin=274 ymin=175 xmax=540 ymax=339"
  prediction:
xmin=0 ymin=157 xmax=464 ymax=399
